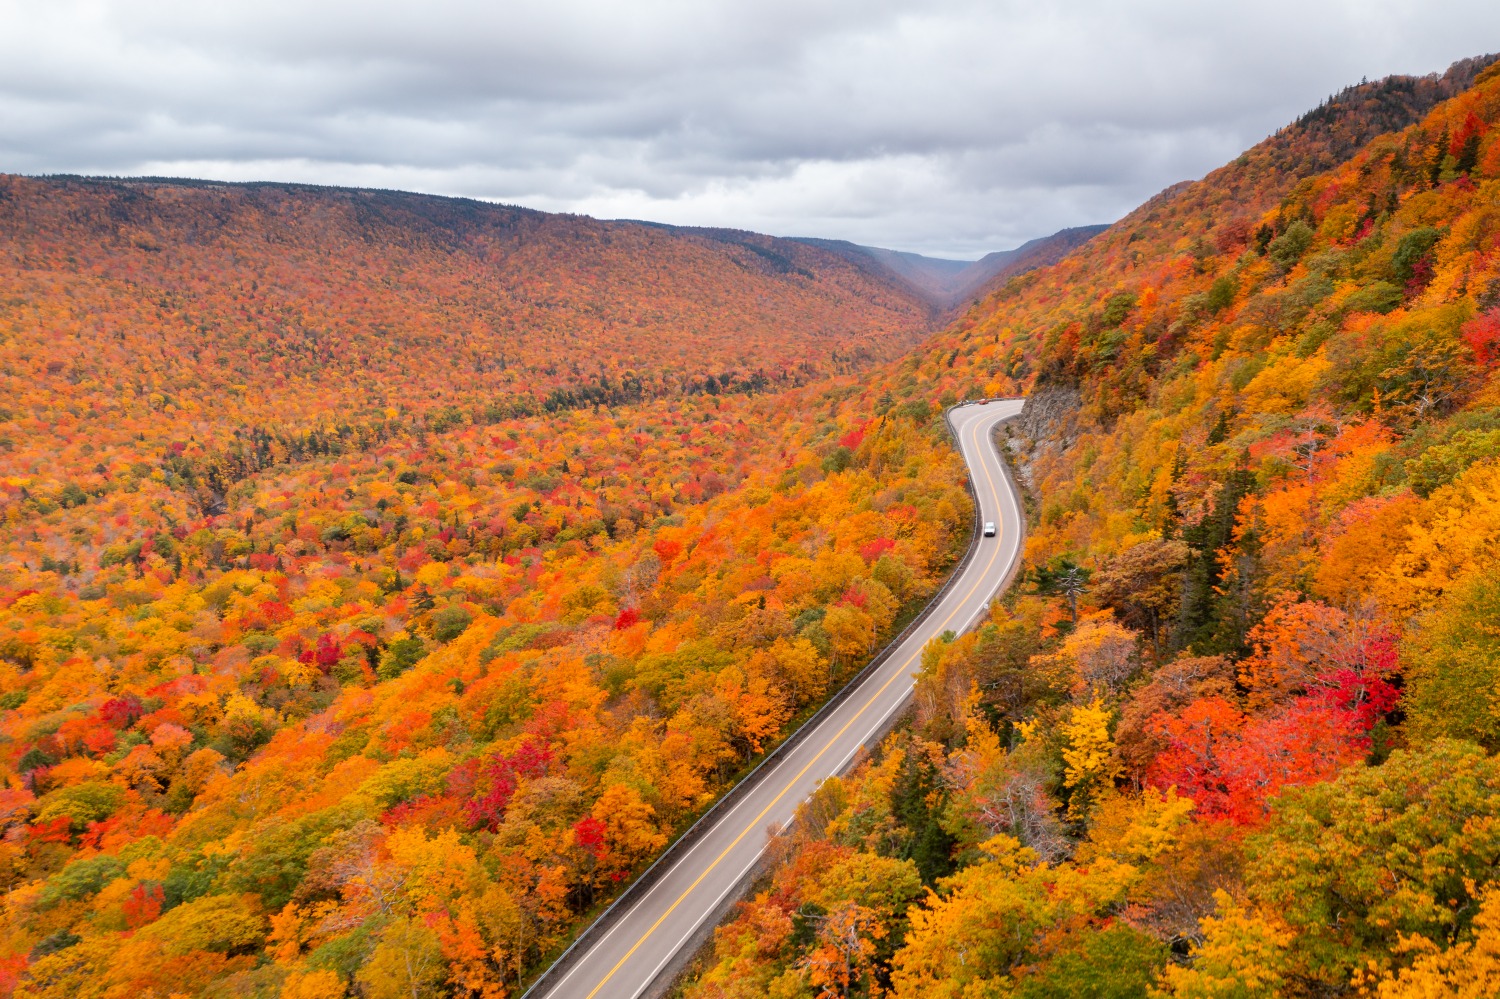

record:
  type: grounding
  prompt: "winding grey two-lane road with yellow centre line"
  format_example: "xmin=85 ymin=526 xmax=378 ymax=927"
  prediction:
xmin=525 ymin=399 xmax=1023 ymax=999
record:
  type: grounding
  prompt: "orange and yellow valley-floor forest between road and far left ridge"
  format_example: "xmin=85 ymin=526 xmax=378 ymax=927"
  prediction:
xmin=0 ymin=369 xmax=968 ymax=995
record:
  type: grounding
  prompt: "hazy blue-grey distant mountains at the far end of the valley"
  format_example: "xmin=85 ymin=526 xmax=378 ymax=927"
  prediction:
xmin=797 ymin=225 xmax=1109 ymax=312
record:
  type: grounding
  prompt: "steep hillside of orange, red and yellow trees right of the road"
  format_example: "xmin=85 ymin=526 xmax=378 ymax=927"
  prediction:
xmin=686 ymin=60 xmax=1500 ymax=999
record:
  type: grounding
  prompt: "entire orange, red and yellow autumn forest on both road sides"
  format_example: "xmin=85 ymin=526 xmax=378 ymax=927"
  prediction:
xmin=0 ymin=50 xmax=1500 ymax=999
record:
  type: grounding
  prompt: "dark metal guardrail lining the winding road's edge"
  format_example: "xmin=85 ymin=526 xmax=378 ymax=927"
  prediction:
xmin=521 ymin=398 xmax=1025 ymax=999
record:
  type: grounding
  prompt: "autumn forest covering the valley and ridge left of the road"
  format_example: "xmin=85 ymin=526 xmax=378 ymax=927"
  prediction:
xmin=0 ymin=179 xmax=969 ymax=996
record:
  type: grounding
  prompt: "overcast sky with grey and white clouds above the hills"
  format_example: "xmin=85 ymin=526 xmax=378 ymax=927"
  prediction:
xmin=0 ymin=0 xmax=1500 ymax=257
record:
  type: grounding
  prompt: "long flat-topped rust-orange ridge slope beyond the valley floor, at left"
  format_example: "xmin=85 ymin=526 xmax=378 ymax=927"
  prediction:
xmin=0 ymin=177 xmax=929 ymax=507
